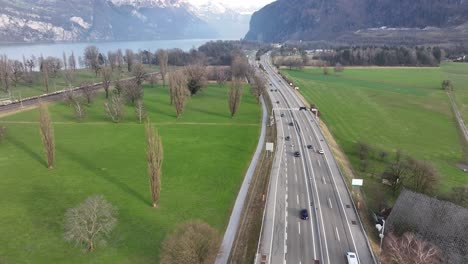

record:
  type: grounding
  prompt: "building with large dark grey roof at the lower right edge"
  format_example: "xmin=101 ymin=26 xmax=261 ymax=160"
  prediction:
xmin=385 ymin=190 xmax=468 ymax=264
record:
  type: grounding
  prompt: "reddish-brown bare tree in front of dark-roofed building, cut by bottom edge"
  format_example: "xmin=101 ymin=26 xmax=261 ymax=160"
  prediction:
xmin=383 ymin=233 xmax=442 ymax=264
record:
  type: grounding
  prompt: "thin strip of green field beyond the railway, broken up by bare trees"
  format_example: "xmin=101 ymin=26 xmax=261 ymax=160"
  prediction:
xmin=0 ymin=65 xmax=158 ymax=100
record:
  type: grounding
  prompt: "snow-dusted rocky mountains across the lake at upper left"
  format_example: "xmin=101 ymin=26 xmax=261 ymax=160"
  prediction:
xmin=0 ymin=0 xmax=218 ymax=42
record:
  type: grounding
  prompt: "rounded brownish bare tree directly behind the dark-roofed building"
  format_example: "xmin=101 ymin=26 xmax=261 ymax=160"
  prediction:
xmin=405 ymin=158 xmax=439 ymax=194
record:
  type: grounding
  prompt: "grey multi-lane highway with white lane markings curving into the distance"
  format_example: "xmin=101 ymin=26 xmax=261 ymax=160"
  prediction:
xmin=256 ymin=55 xmax=375 ymax=264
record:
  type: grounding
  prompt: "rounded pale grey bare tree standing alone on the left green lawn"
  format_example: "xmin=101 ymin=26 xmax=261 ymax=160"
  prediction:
xmin=64 ymin=195 xmax=117 ymax=252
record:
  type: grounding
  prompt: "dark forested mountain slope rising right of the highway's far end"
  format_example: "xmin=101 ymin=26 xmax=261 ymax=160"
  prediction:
xmin=245 ymin=0 xmax=468 ymax=42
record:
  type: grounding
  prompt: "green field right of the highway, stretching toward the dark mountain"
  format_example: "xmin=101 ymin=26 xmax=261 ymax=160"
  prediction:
xmin=284 ymin=68 xmax=468 ymax=206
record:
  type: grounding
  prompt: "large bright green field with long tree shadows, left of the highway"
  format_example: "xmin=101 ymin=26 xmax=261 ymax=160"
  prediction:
xmin=0 ymin=85 xmax=260 ymax=263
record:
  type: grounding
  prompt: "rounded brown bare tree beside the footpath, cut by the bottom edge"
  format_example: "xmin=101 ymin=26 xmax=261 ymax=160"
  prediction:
xmin=161 ymin=221 xmax=221 ymax=264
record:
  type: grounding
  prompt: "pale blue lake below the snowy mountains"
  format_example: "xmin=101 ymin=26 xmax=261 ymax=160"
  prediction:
xmin=0 ymin=39 xmax=217 ymax=61
